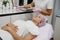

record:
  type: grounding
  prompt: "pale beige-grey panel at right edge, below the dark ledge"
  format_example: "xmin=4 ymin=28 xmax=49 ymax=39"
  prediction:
xmin=54 ymin=18 xmax=60 ymax=40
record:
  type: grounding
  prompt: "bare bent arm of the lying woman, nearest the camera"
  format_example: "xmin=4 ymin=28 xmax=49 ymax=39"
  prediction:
xmin=9 ymin=30 xmax=35 ymax=40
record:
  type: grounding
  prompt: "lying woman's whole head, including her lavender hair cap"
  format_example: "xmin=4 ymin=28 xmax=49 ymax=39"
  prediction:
xmin=32 ymin=14 xmax=45 ymax=25
